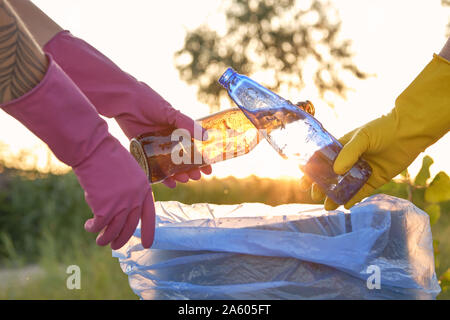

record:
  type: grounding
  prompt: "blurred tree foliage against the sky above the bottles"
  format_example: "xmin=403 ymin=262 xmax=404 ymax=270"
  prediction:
xmin=175 ymin=0 xmax=368 ymax=111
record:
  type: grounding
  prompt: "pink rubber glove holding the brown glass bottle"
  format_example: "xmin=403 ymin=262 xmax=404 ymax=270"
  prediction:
xmin=44 ymin=31 xmax=211 ymax=188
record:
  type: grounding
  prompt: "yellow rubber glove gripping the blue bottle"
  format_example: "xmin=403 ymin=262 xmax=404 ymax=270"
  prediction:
xmin=301 ymin=55 xmax=450 ymax=210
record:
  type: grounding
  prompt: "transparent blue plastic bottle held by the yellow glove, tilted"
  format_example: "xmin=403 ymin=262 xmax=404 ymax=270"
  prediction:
xmin=219 ymin=68 xmax=372 ymax=204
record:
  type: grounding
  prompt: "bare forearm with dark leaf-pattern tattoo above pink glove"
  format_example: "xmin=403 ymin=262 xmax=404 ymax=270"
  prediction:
xmin=0 ymin=0 xmax=47 ymax=102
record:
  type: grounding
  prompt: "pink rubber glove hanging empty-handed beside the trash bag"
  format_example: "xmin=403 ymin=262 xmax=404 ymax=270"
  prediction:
xmin=1 ymin=57 xmax=155 ymax=249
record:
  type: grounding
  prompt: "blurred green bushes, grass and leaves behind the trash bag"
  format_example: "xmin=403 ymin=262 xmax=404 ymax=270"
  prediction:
xmin=0 ymin=157 xmax=450 ymax=299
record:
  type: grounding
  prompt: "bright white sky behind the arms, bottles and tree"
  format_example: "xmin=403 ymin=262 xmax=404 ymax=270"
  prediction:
xmin=0 ymin=0 xmax=450 ymax=178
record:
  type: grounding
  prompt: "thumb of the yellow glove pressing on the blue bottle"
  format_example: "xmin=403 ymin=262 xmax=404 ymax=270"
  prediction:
xmin=333 ymin=130 xmax=369 ymax=174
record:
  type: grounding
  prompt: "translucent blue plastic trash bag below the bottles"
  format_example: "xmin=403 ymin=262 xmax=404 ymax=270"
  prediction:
xmin=113 ymin=195 xmax=440 ymax=300
